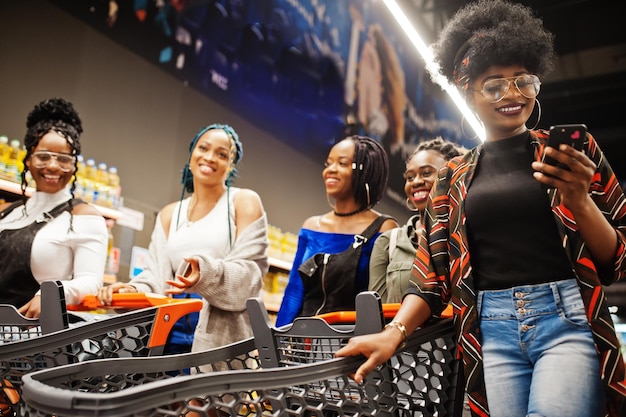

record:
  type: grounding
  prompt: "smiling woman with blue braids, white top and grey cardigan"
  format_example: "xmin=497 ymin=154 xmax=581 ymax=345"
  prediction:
xmin=99 ymin=124 xmax=269 ymax=353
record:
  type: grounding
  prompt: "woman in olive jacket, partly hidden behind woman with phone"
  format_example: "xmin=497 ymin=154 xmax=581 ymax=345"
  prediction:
xmin=369 ymin=137 xmax=466 ymax=303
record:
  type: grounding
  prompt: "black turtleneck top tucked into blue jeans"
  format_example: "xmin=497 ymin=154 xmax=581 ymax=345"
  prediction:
xmin=465 ymin=132 xmax=574 ymax=290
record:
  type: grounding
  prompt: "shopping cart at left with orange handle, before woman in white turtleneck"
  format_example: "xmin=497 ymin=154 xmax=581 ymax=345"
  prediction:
xmin=0 ymin=281 xmax=202 ymax=416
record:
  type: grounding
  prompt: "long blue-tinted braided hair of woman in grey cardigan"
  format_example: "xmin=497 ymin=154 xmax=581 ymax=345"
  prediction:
xmin=176 ymin=123 xmax=243 ymax=247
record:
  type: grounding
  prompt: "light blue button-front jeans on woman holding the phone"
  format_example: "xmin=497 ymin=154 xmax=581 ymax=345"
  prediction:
xmin=478 ymin=279 xmax=606 ymax=417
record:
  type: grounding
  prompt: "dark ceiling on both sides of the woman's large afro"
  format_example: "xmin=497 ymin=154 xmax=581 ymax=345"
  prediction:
xmin=403 ymin=0 xmax=626 ymax=179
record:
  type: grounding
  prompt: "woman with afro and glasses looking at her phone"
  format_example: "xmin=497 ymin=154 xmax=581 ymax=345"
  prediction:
xmin=337 ymin=0 xmax=626 ymax=417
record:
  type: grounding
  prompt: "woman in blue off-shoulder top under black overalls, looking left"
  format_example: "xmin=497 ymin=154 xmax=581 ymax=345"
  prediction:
xmin=276 ymin=136 xmax=398 ymax=326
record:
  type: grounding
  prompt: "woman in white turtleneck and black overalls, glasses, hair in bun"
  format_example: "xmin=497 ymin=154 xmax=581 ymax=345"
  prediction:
xmin=0 ymin=98 xmax=108 ymax=318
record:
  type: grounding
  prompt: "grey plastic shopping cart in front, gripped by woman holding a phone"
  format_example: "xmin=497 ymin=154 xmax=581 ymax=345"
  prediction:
xmin=22 ymin=293 xmax=463 ymax=417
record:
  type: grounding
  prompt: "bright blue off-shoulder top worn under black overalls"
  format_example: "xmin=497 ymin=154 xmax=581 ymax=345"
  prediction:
xmin=276 ymin=229 xmax=380 ymax=326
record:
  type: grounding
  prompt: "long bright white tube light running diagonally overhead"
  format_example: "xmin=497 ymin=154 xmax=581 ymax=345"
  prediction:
xmin=383 ymin=0 xmax=485 ymax=142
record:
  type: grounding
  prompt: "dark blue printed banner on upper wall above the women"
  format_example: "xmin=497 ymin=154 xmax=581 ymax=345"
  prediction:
xmin=50 ymin=0 xmax=475 ymax=203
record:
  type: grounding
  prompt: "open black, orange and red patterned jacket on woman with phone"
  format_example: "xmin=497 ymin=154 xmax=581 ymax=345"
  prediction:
xmin=409 ymin=130 xmax=626 ymax=417
